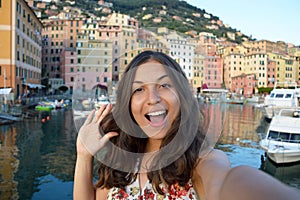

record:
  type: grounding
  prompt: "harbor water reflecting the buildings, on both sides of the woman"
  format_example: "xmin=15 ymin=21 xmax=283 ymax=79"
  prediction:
xmin=0 ymin=103 xmax=300 ymax=200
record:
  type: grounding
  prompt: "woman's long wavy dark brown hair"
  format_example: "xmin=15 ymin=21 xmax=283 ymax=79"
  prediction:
xmin=96 ymin=51 xmax=206 ymax=194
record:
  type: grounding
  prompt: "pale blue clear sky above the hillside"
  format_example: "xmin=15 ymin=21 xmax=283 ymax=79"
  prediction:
xmin=185 ymin=0 xmax=300 ymax=46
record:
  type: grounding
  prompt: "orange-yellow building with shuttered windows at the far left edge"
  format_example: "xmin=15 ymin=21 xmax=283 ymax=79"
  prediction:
xmin=0 ymin=0 xmax=42 ymax=96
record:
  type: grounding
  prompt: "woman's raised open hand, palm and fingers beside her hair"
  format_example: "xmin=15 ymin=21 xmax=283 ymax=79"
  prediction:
xmin=76 ymin=104 xmax=118 ymax=157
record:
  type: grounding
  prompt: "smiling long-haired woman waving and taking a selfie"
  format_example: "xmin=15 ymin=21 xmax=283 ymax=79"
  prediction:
xmin=74 ymin=51 xmax=300 ymax=200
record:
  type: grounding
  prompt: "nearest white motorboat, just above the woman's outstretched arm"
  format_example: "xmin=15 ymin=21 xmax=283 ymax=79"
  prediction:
xmin=260 ymin=109 xmax=300 ymax=163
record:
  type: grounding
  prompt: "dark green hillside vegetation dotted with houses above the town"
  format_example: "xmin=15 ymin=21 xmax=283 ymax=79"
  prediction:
xmin=57 ymin=0 xmax=251 ymax=43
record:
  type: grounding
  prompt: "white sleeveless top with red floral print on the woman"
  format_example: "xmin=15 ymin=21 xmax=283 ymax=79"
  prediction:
xmin=107 ymin=180 xmax=198 ymax=200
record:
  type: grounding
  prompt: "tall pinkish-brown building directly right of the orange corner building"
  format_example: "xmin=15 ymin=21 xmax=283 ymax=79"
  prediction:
xmin=42 ymin=19 xmax=83 ymax=92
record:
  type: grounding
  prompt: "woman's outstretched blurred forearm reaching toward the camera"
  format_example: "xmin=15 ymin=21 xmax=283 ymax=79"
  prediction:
xmin=220 ymin=166 xmax=300 ymax=200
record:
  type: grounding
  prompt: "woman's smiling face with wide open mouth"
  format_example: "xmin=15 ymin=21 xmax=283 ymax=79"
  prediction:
xmin=131 ymin=61 xmax=180 ymax=139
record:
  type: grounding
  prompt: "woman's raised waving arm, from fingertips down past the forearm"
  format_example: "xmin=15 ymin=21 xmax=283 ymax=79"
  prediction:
xmin=73 ymin=105 xmax=118 ymax=200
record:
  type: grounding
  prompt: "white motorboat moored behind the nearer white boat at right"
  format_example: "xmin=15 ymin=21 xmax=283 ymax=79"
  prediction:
xmin=257 ymin=83 xmax=300 ymax=120
